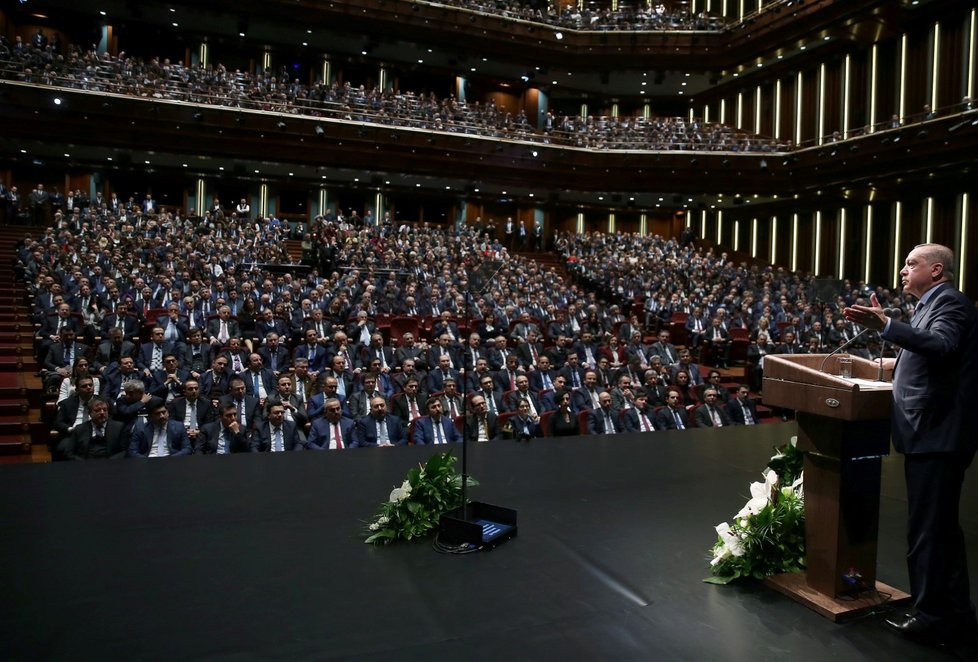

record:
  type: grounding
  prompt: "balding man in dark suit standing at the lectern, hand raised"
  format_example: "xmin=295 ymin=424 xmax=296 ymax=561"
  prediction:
xmin=844 ymin=244 xmax=978 ymax=659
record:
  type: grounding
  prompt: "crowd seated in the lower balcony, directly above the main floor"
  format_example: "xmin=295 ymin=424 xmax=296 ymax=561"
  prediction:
xmin=0 ymin=40 xmax=776 ymax=151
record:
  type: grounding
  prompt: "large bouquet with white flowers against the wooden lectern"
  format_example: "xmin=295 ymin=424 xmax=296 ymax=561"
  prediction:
xmin=704 ymin=437 xmax=805 ymax=584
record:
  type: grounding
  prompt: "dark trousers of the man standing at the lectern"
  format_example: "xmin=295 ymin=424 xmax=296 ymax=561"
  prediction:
xmin=904 ymin=452 xmax=975 ymax=630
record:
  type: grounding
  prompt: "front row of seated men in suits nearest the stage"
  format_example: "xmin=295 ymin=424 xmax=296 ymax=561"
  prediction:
xmin=54 ymin=377 xmax=759 ymax=460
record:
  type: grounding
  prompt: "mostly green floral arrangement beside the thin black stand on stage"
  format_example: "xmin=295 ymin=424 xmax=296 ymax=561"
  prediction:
xmin=364 ymin=453 xmax=479 ymax=545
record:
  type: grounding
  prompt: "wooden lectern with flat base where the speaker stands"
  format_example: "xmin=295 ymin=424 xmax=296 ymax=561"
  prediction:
xmin=763 ymin=354 xmax=910 ymax=621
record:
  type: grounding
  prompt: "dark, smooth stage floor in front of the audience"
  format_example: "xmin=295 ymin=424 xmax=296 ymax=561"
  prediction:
xmin=0 ymin=424 xmax=978 ymax=662
